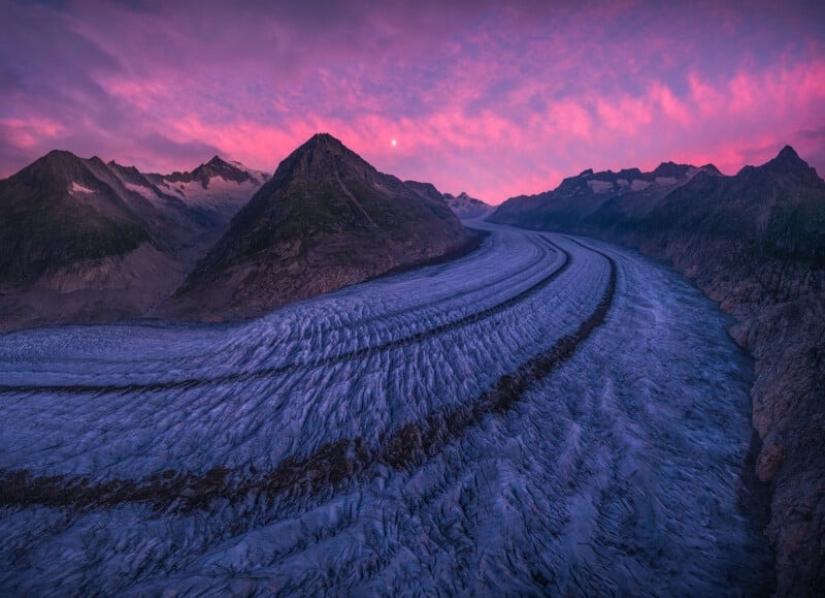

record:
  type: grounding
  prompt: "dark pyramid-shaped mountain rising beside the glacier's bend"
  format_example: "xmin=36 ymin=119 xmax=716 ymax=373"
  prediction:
xmin=160 ymin=134 xmax=476 ymax=319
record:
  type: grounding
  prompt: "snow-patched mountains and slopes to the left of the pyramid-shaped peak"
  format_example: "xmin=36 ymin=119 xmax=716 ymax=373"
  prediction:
xmin=0 ymin=151 xmax=268 ymax=331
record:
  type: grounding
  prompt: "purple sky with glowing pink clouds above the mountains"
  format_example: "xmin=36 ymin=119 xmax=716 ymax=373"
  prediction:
xmin=0 ymin=0 xmax=825 ymax=203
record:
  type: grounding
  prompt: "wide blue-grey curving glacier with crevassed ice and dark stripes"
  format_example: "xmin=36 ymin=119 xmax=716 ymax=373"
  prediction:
xmin=0 ymin=226 xmax=771 ymax=596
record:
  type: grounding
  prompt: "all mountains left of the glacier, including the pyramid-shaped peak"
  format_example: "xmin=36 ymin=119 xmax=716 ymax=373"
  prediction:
xmin=0 ymin=134 xmax=479 ymax=332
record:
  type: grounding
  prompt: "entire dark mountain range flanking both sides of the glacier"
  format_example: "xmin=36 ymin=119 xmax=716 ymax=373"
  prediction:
xmin=0 ymin=134 xmax=825 ymax=595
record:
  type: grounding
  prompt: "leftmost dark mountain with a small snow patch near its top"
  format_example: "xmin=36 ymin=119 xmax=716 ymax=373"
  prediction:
xmin=0 ymin=151 xmax=183 ymax=331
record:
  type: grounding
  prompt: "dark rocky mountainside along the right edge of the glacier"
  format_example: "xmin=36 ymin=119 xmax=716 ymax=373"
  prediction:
xmin=490 ymin=147 xmax=825 ymax=596
